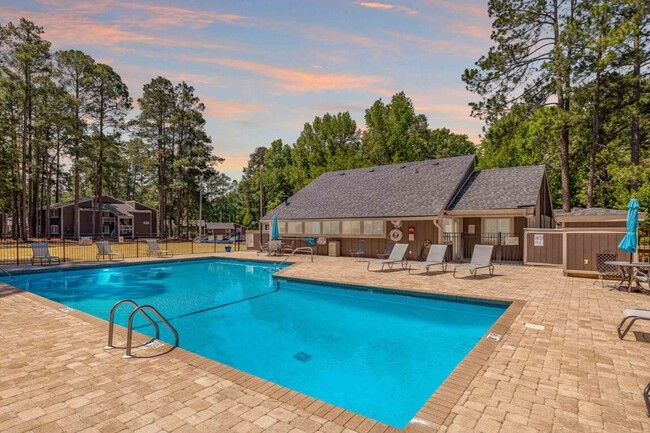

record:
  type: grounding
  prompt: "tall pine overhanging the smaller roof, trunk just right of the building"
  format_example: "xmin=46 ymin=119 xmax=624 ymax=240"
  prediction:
xmin=462 ymin=0 xmax=578 ymax=211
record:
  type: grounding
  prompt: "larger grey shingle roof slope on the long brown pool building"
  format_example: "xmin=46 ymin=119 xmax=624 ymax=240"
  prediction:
xmin=263 ymin=155 xmax=474 ymax=220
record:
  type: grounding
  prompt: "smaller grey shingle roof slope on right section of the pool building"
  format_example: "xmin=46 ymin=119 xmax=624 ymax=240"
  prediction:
xmin=449 ymin=165 xmax=545 ymax=210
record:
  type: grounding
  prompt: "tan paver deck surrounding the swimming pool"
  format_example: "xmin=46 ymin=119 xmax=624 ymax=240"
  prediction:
xmin=0 ymin=252 xmax=650 ymax=433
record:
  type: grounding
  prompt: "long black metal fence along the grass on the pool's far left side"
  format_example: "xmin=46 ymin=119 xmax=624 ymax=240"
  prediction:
xmin=0 ymin=237 xmax=246 ymax=265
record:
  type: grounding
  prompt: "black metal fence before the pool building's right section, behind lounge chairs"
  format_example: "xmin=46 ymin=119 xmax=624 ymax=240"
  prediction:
xmin=443 ymin=233 xmax=524 ymax=263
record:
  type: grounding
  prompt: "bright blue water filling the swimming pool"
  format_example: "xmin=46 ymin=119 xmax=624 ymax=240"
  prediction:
xmin=0 ymin=259 xmax=507 ymax=428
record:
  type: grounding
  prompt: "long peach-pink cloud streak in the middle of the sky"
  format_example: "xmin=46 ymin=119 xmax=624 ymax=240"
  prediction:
xmin=182 ymin=56 xmax=385 ymax=92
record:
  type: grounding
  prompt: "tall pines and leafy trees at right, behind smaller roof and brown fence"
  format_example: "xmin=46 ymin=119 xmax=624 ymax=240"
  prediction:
xmin=463 ymin=0 xmax=650 ymax=211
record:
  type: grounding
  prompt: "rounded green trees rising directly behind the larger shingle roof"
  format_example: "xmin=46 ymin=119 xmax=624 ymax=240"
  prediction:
xmin=233 ymin=92 xmax=476 ymax=227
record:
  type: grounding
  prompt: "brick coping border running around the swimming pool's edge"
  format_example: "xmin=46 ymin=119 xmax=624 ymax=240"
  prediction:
xmin=0 ymin=255 xmax=527 ymax=433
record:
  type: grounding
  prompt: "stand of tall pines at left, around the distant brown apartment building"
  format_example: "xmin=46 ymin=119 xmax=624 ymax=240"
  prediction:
xmin=0 ymin=19 xmax=220 ymax=239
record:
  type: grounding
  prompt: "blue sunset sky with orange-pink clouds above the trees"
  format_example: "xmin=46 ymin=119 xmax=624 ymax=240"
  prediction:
xmin=0 ymin=0 xmax=490 ymax=179
